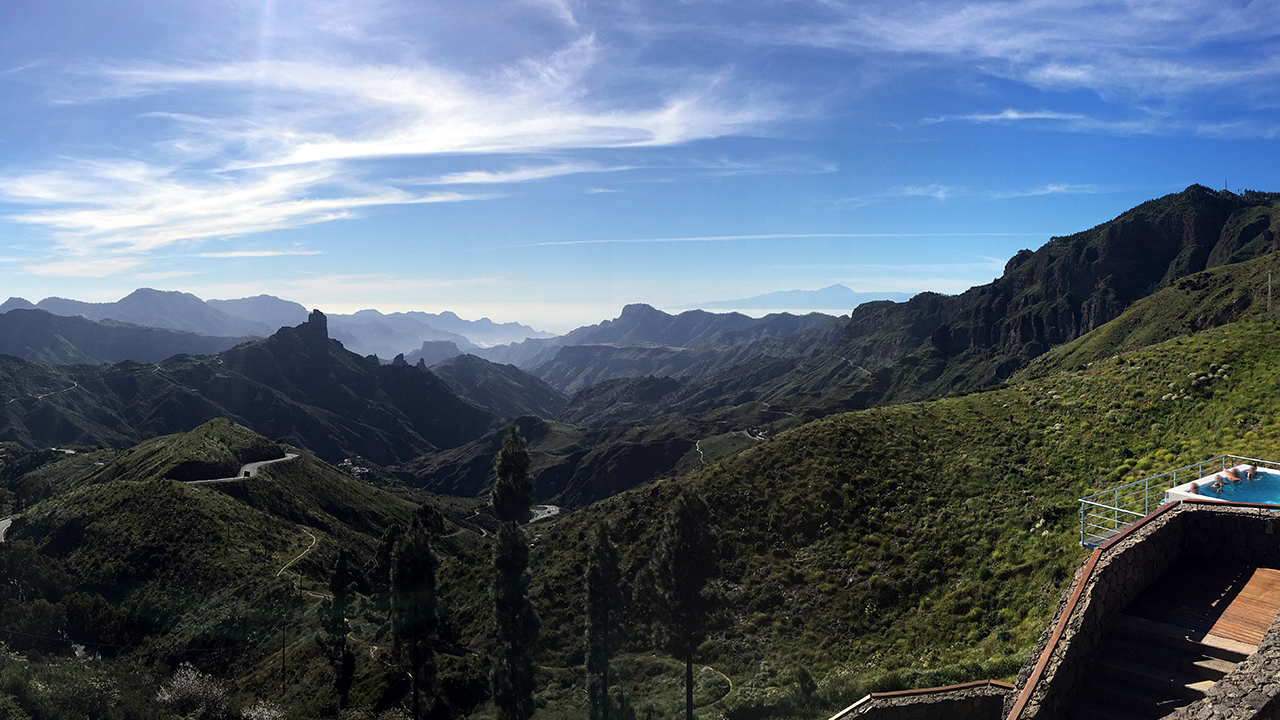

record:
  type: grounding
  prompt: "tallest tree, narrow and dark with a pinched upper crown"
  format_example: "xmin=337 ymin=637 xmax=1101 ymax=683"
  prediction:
xmin=489 ymin=425 xmax=539 ymax=720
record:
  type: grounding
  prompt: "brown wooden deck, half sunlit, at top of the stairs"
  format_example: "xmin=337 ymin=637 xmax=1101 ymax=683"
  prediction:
xmin=1128 ymin=559 xmax=1280 ymax=647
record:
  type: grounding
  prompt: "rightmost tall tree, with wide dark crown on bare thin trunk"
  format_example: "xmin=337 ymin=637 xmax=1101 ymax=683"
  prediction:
xmin=653 ymin=489 xmax=717 ymax=720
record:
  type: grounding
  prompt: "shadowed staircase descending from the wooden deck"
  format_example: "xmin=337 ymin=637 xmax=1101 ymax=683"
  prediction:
xmin=1068 ymin=614 xmax=1257 ymax=720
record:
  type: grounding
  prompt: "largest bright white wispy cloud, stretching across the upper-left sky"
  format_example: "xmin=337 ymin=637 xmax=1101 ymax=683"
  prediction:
xmin=86 ymin=36 xmax=782 ymax=167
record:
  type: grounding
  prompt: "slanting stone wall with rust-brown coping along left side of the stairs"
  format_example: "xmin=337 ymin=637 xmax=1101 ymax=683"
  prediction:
xmin=1018 ymin=507 xmax=1185 ymax=720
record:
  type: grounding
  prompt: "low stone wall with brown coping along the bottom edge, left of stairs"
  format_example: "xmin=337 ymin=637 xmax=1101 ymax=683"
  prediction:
xmin=831 ymin=680 xmax=1015 ymax=720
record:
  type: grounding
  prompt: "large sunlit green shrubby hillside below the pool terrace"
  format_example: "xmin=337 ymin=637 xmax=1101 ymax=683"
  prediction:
xmin=514 ymin=311 xmax=1280 ymax=714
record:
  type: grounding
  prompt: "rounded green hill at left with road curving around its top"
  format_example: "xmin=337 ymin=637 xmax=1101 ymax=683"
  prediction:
xmin=10 ymin=423 xmax=424 ymax=716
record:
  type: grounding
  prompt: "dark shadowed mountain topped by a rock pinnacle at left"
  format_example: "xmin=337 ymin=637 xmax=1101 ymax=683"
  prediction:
xmin=0 ymin=313 xmax=495 ymax=464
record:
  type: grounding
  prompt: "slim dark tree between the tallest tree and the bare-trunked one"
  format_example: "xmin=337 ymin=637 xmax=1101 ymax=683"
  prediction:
xmin=586 ymin=521 xmax=625 ymax=720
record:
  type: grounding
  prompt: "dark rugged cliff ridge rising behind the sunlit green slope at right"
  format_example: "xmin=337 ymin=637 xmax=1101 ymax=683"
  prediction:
xmin=680 ymin=184 xmax=1280 ymax=411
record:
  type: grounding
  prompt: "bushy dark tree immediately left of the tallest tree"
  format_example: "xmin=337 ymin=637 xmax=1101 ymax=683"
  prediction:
xmin=390 ymin=505 xmax=440 ymax=720
